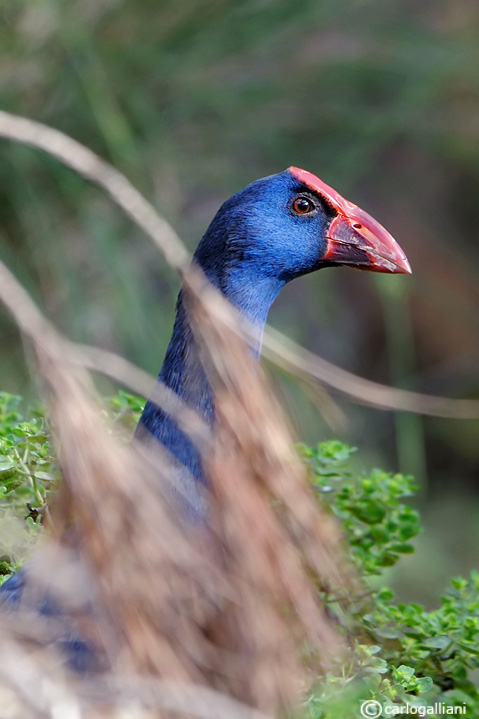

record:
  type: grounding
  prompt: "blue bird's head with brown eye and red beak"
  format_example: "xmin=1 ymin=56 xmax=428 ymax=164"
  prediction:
xmin=196 ymin=167 xmax=411 ymax=284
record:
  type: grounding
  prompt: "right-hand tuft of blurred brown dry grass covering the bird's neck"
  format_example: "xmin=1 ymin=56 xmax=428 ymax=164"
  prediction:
xmin=185 ymin=272 xmax=354 ymax=707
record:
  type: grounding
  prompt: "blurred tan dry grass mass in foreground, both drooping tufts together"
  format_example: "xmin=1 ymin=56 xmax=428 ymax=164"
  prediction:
xmin=0 ymin=260 xmax=350 ymax=712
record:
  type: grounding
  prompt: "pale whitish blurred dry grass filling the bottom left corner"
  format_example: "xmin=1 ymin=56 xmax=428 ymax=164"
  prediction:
xmin=0 ymin=620 xmax=272 ymax=719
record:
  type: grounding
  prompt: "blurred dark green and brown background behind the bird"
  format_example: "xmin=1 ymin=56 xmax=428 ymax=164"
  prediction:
xmin=0 ymin=0 xmax=479 ymax=601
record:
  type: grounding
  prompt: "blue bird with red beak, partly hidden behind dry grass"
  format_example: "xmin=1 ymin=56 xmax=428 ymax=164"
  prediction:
xmin=0 ymin=167 xmax=411 ymax=671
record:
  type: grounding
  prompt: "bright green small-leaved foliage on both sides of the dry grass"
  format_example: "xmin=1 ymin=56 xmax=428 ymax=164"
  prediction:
xmin=0 ymin=400 xmax=479 ymax=719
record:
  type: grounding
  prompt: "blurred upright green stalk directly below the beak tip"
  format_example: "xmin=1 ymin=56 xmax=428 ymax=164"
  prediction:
xmin=374 ymin=275 xmax=427 ymax=489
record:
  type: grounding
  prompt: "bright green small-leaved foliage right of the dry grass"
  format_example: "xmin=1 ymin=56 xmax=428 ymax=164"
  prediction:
xmin=299 ymin=441 xmax=479 ymax=719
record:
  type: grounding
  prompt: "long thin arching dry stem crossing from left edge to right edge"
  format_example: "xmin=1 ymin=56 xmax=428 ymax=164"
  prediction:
xmin=0 ymin=111 xmax=479 ymax=419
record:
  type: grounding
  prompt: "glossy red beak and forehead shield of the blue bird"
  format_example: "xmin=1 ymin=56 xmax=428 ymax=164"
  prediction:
xmin=290 ymin=167 xmax=411 ymax=274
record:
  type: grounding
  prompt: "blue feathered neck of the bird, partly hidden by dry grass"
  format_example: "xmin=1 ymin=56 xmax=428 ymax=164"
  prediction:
xmin=137 ymin=258 xmax=283 ymax=504
